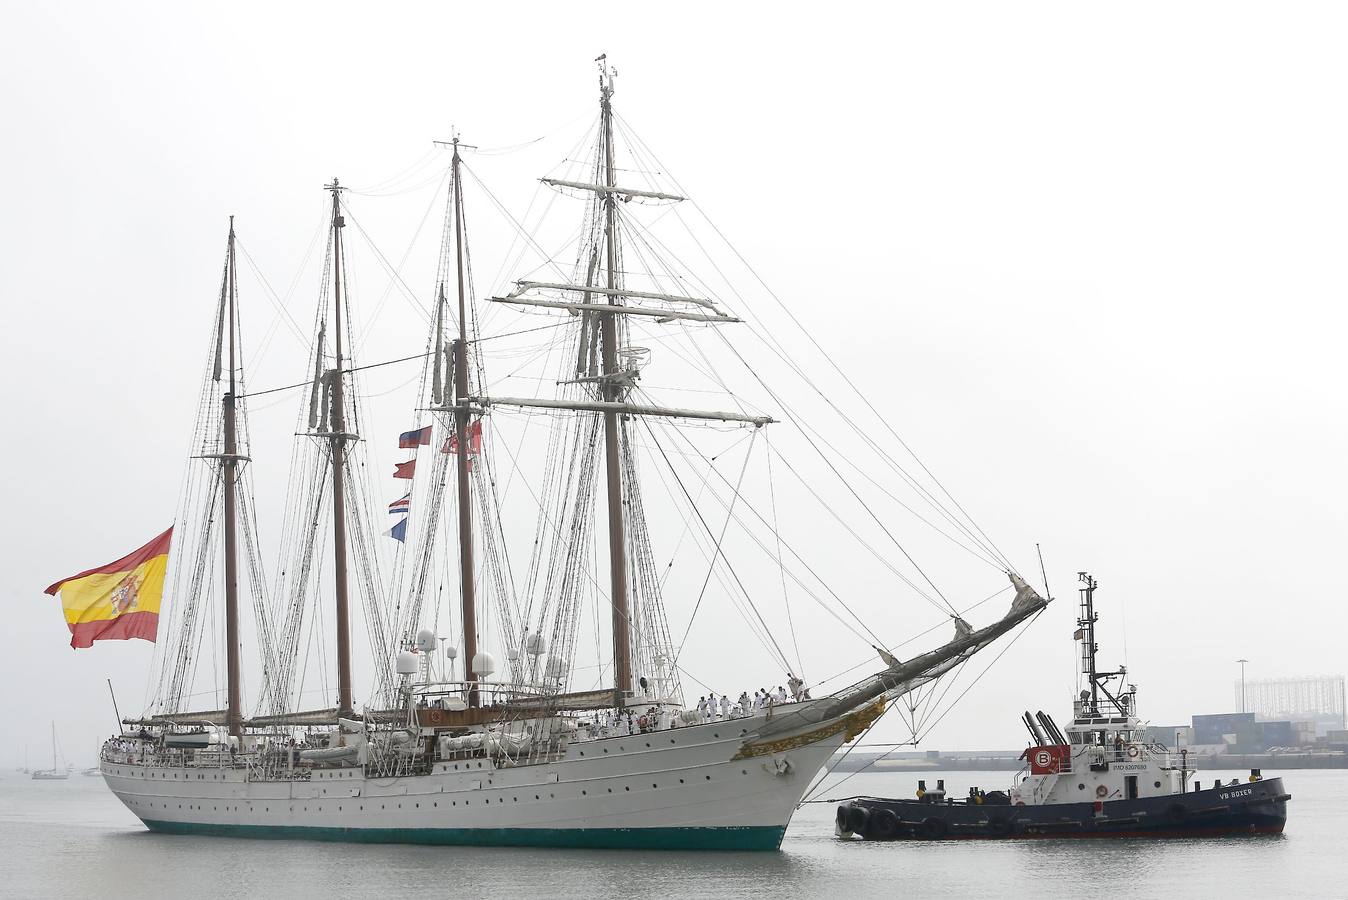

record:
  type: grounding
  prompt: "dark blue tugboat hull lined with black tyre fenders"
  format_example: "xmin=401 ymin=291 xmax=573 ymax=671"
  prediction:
xmin=837 ymin=779 xmax=1291 ymax=841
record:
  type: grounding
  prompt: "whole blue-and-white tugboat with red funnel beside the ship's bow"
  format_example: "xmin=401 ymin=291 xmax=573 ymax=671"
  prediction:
xmin=837 ymin=573 xmax=1291 ymax=841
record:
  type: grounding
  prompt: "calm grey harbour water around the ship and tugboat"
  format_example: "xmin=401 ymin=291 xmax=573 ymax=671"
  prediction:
xmin=0 ymin=771 xmax=1348 ymax=900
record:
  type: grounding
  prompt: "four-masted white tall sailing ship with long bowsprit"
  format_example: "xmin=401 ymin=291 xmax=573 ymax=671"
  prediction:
xmin=86 ymin=58 xmax=1046 ymax=849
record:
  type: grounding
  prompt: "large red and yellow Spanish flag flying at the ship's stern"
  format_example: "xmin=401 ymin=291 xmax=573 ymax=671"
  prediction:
xmin=47 ymin=528 xmax=173 ymax=649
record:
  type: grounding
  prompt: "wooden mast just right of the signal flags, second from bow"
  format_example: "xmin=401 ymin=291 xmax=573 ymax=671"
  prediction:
xmin=450 ymin=136 xmax=481 ymax=706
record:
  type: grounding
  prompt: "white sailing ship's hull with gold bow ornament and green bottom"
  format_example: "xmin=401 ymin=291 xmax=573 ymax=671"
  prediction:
xmin=102 ymin=709 xmax=879 ymax=850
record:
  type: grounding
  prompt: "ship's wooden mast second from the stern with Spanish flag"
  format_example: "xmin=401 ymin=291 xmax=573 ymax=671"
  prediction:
xmin=328 ymin=178 xmax=352 ymax=715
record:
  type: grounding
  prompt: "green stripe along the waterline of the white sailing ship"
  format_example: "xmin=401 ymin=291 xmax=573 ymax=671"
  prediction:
xmin=144 ymin=819 xmax=786 ymax=850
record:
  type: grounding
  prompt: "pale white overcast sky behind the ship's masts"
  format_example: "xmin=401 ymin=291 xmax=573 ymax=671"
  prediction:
xmin=0 ymin=3 xmax=1348 ymax=767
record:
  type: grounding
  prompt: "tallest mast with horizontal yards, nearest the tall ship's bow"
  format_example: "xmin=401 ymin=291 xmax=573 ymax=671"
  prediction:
xmin=600 ymin=59 xmax=632 ymax=705
